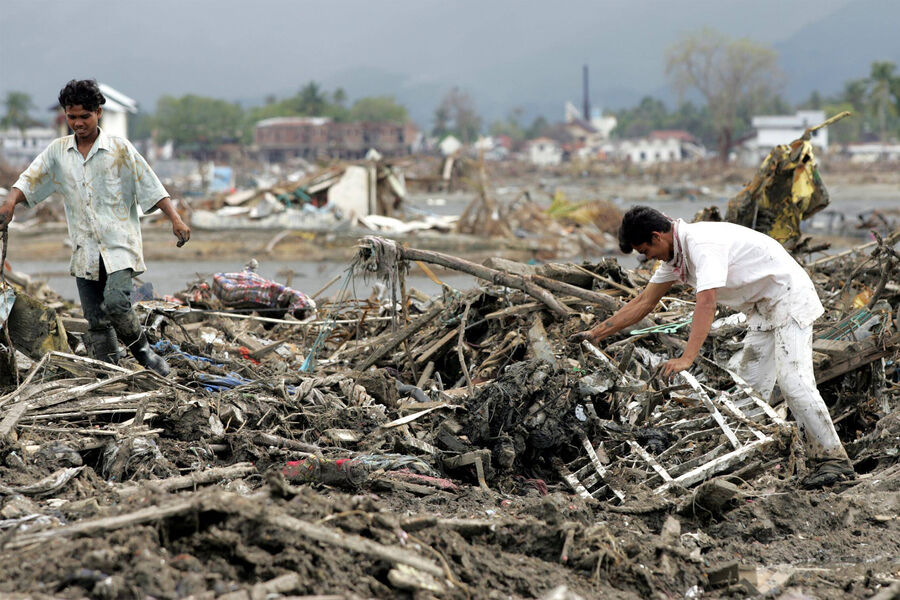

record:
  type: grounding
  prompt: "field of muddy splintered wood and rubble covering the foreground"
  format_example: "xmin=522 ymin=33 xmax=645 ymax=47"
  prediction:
xmin=0 ymin=227 xmax=900 ymax=600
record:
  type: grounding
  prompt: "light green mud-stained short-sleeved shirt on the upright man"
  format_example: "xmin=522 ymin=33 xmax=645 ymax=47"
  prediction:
xmin=14 ymin=130 xmax=169 ymax=281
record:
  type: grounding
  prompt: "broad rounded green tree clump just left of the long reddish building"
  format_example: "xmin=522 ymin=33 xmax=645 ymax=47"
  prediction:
xmin=155 ymin=94 xmax=244 ymax=151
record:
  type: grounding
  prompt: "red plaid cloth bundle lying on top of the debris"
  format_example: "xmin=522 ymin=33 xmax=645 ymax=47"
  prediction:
xmin=212 ymin=271 xmax=316 ymax=315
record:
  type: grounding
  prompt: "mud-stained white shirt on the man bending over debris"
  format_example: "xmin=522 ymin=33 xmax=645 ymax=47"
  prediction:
xmin=650 ymin=219 xmax=824 ymax=331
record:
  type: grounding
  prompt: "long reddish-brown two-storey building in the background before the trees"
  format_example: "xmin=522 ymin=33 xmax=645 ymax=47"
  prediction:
xmin=254 ymin=117 xmax=418 ymax=162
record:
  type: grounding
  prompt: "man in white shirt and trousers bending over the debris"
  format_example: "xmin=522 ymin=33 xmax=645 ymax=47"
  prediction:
xmin=571 ymin=206 xmax=855 ymax=488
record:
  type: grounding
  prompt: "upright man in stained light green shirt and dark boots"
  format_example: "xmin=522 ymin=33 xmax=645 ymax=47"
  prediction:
xmin=0 ymin=79 xmax=191 ymax=375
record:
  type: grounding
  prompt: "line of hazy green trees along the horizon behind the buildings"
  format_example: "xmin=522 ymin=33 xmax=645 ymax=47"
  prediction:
xmin=0 ymin=29 xmax=900 ymax=156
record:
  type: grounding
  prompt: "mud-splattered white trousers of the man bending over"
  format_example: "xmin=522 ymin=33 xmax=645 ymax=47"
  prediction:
xmin=729 ymin=319 xmax=847 ymax=460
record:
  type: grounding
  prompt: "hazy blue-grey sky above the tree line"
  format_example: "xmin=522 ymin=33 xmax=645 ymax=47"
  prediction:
xmin=0 ymin=0 xmax=888 ymax=125
